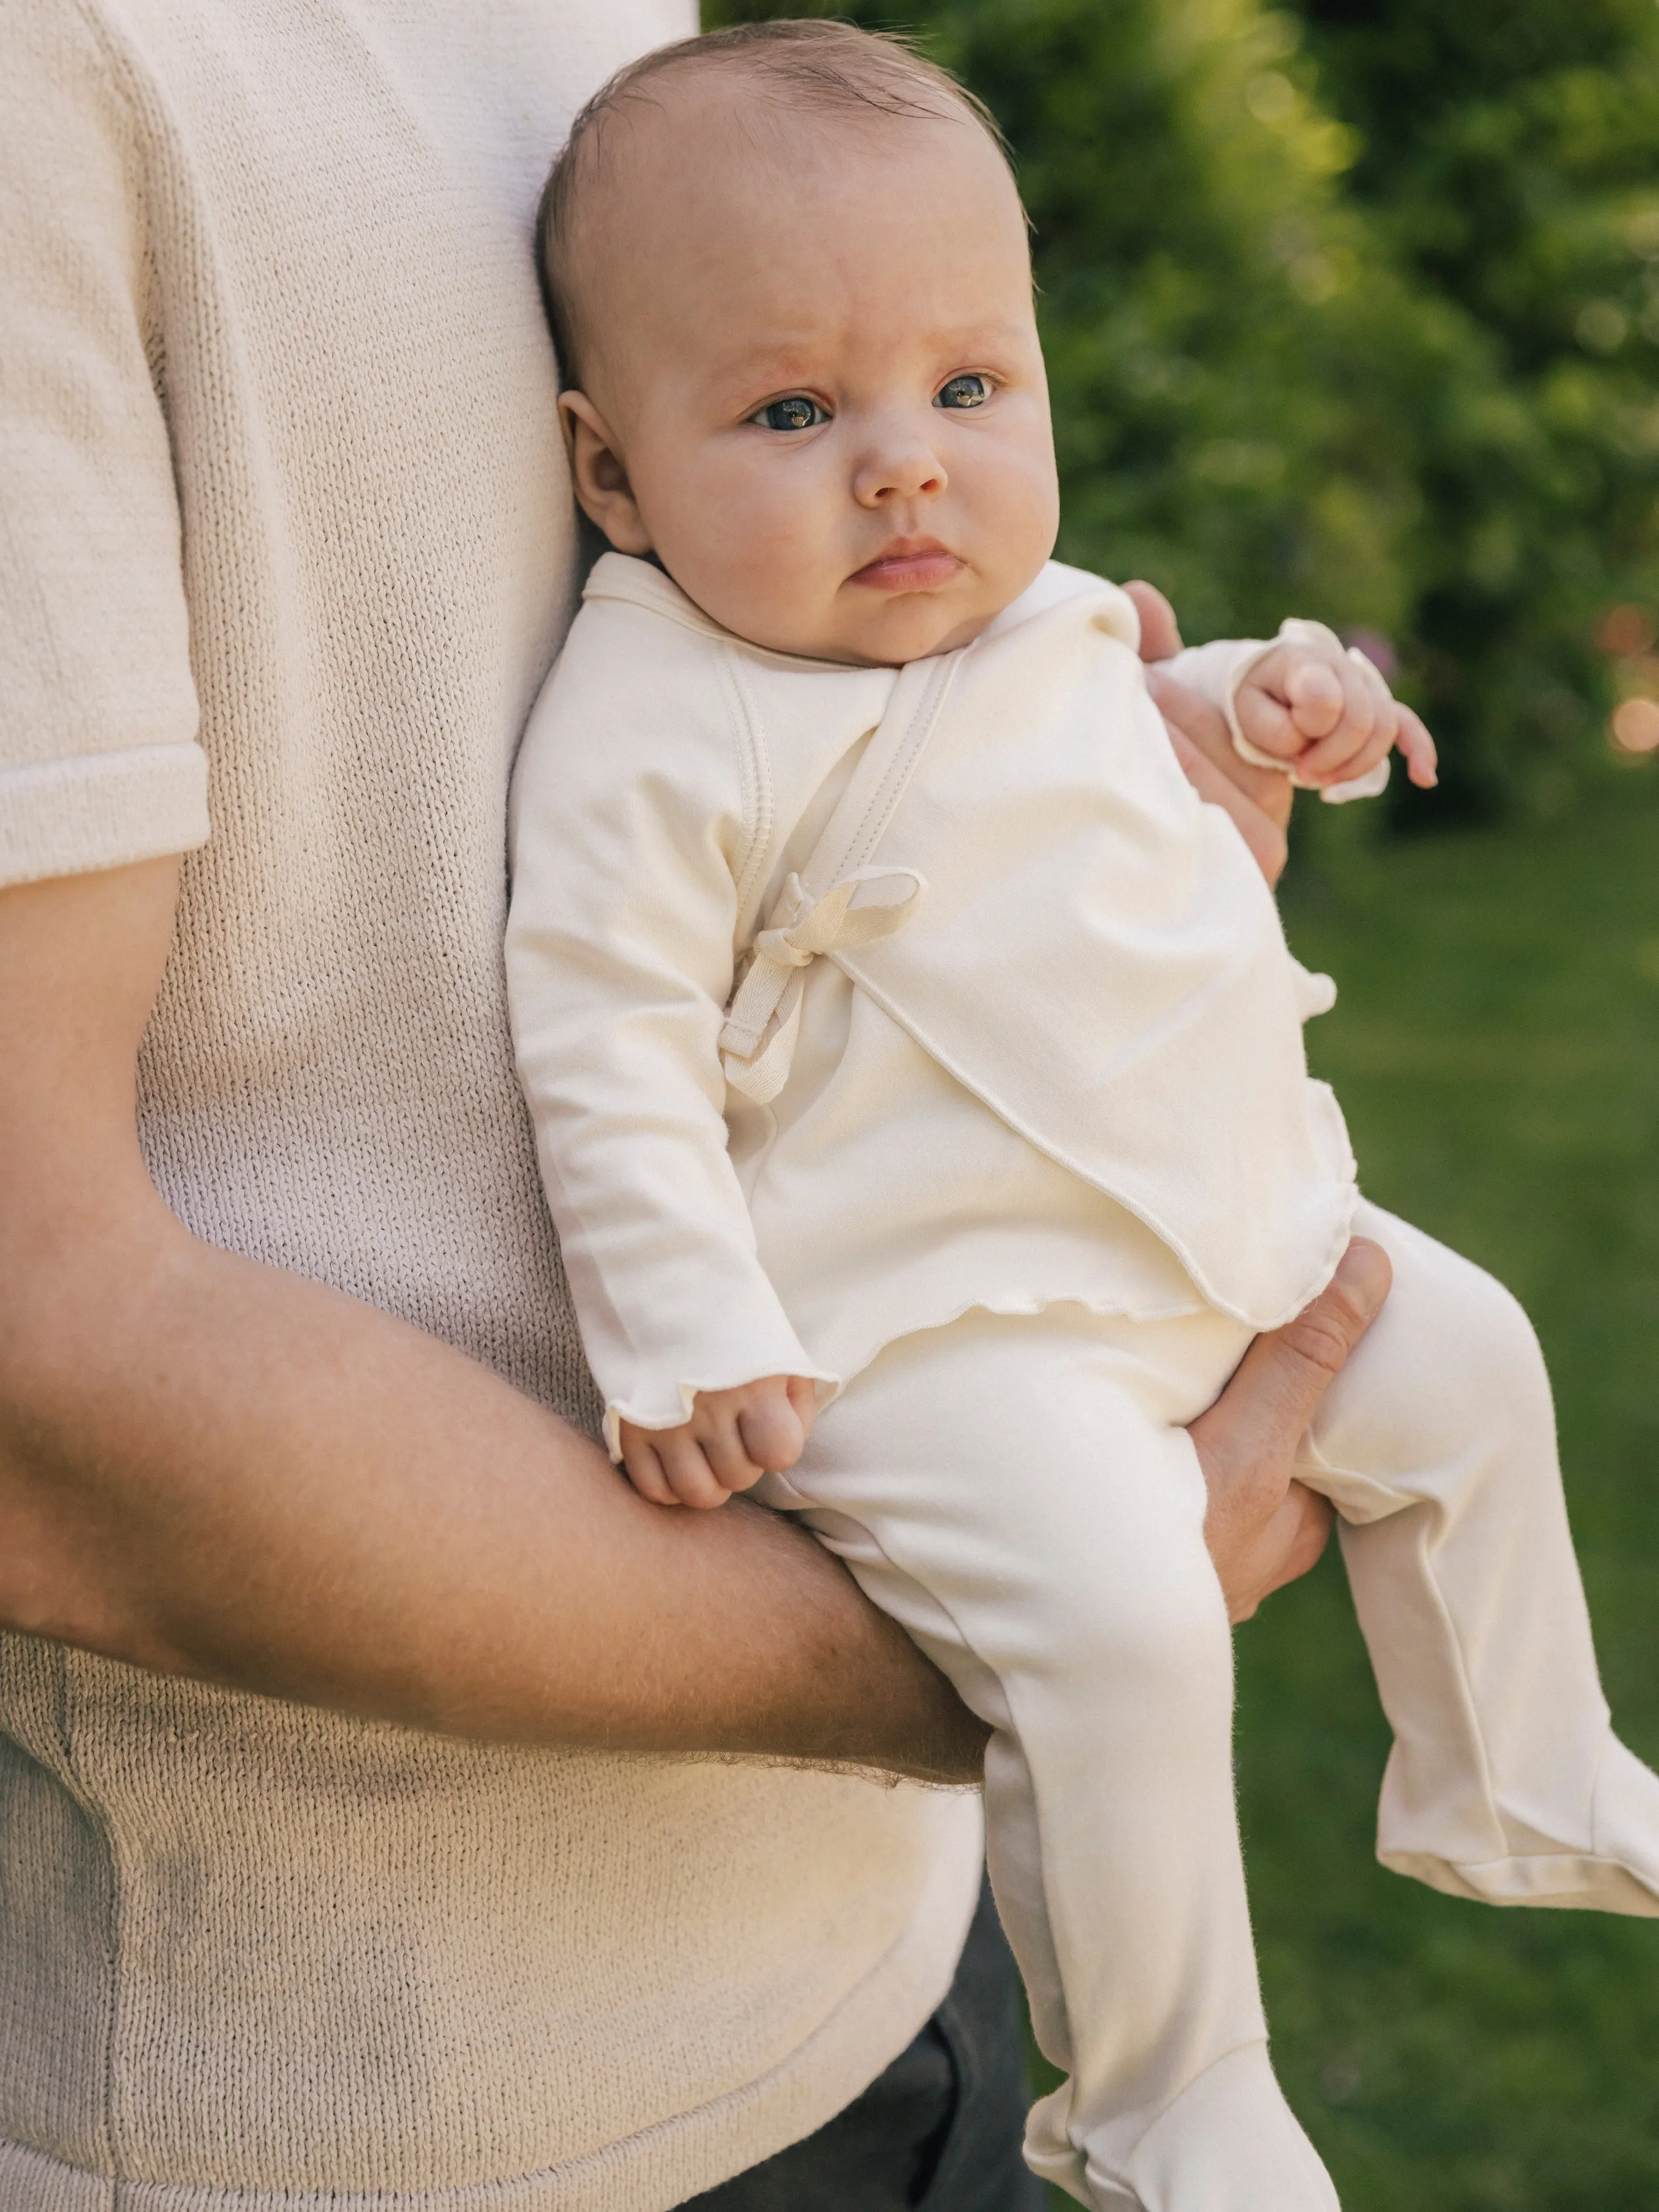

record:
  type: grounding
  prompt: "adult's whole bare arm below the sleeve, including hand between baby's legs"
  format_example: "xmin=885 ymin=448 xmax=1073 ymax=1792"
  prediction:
xmin=0 ymin=860 xmax=1385 ymax=1781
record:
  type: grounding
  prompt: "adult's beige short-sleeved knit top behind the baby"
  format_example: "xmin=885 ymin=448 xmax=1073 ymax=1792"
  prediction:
xmin=0 ymin=0 xmax=978 ymax=2212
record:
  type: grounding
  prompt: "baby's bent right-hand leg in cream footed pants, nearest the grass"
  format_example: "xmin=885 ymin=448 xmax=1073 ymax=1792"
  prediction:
xmin=1298 ymin=1205 xmax=1659 ymax=1913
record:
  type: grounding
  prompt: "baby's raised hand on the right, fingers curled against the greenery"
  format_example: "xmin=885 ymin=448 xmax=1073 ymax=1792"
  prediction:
xmin=1232 ymin=640 xmax=1438 ymax=790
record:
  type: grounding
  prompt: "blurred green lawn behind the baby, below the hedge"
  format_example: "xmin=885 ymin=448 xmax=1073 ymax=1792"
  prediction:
xmin=1035 ymin=767 xmax=1659 ymax=2212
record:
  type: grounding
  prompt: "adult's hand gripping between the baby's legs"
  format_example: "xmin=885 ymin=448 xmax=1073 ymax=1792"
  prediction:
xmin=1190 ymin=1237 xmax=1391 ymax=1621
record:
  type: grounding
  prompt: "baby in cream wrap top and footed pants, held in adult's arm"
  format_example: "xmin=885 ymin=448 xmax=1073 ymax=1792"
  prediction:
xmin=507 ymin=22 xmax=1659 ymax=2212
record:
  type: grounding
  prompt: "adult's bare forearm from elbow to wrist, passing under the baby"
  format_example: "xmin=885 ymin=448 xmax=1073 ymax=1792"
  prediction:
xmin=0 ymin=1201 xmax=982 ymax=1781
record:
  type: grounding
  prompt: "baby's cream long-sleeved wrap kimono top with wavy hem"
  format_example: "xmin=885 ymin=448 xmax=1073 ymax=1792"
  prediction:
xmin=507 ymin=553 xmax=1354 ymax=1451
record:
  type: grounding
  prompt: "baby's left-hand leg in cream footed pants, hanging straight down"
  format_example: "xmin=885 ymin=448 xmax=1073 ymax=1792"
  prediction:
xmin=768 ymin=1310 xmax=1336 ymax=2212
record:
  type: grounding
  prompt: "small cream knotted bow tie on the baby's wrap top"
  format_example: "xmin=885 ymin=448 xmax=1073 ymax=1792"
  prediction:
xmin=721 ymin=867 xmax=927 ymax=1106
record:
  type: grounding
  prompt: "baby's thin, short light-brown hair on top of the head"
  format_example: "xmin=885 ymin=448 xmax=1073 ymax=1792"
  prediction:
xmin=535 ymin=20 xmax=1013 ymax=383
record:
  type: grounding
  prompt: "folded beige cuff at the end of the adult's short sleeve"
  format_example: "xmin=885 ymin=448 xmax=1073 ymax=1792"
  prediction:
xmin=0 ymin=743 xmax=208 ymax=887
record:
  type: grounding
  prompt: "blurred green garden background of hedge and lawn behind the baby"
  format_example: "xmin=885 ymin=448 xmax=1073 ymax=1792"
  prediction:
xmin=706 ymin=0 xmax=1659 ymax=2212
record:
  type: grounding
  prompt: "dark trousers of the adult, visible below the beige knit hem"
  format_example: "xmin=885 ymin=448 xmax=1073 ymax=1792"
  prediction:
xmin=681 ymin=1887 xmax=1044 ymax=2212
